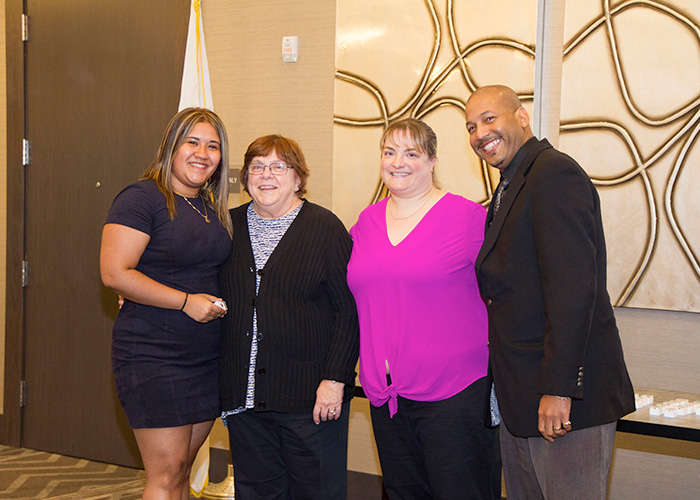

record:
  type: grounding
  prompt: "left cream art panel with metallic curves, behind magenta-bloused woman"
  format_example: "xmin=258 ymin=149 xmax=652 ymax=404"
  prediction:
xmin=333 ymin=0 xmax=537 ymax=226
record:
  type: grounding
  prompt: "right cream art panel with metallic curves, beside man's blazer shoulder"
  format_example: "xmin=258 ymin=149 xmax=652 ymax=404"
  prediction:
xmin=559 ymin=0 xmax=700 ymax=312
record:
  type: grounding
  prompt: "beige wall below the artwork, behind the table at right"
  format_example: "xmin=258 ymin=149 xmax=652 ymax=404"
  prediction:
xmin=609 ymin=308 xmax=700 ymax=500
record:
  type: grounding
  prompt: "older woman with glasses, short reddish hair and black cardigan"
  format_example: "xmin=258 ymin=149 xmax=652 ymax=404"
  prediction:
xmin=220 ymin=135 xmax=359 ymax=500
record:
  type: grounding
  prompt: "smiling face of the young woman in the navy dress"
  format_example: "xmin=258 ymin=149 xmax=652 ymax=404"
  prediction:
xmin=171 ymin=122 xmax=221 ymax=196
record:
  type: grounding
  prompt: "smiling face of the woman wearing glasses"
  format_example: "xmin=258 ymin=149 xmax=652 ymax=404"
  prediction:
xmin=248 ymin=150 xmax=301 ymax=219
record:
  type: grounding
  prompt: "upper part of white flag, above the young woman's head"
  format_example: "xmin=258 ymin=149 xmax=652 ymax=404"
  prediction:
xmin=178 ymin=0 xmax=214 ymax=111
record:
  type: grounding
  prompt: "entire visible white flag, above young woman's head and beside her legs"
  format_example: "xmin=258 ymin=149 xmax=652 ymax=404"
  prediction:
xmin=178 ymin=0 xmax=214 ymax=498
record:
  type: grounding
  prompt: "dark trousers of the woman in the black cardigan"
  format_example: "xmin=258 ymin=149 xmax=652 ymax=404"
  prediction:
xmin=226 ymin=402 xmax=350 ymax=500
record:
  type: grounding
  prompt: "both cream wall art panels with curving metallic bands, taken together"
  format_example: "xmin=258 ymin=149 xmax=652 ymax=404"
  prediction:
xmin=333 ymin=0 xmax=700 ymax=311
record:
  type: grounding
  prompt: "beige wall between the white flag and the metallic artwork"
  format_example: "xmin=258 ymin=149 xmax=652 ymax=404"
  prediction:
xmin=202 ymin=0 xmax=335 ymax=208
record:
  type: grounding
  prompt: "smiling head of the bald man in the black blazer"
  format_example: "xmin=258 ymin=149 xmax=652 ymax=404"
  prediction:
xmin=465 ymin=87 xmax=532 ymax=170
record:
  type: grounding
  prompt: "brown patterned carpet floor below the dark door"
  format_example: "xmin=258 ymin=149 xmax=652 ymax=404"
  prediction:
xmin=0 ymin=445 xmax=382 ymax=500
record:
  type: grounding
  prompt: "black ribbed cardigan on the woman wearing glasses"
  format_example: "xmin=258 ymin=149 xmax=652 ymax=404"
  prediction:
xmin=219 ymin=201 xmax=359 ymax=413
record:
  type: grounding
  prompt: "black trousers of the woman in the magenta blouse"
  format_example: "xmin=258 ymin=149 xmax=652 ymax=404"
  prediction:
xmin=370 ymin=378 xmax=501 ymax=500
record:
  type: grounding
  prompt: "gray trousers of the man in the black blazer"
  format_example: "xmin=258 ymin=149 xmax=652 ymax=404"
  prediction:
xmin=500 ymin=422 xmax=617 ymax=500
